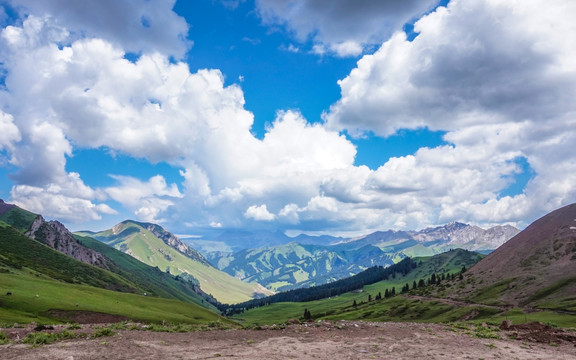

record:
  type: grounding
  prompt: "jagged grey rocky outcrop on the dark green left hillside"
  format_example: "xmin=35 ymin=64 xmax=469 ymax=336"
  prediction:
xmin=26 ymin=215 xmax=109 ymax=270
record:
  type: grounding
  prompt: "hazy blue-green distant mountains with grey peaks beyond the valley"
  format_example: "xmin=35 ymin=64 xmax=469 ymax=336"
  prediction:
xmin=206 ymin=223 xmax=519 ymax=291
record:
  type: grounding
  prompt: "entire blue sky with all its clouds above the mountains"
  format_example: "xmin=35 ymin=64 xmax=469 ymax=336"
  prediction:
xmin=0 ymin=0 xmax=576 ymax=235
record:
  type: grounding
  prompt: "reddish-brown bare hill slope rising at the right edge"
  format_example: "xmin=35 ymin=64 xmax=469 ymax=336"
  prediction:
xmin=450 ymin=204 xmax=576 ymax=311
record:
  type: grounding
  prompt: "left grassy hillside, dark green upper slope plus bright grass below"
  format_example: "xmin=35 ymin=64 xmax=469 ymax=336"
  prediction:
xmin=0 ymin=228 xmax=230 ymax=323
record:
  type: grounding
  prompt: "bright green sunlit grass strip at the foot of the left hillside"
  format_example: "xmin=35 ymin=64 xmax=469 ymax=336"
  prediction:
xmin=0 ymin=269 xmax=234 ymax=324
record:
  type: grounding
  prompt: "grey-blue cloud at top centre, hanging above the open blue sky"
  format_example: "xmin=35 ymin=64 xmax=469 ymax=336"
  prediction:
xmin=256 ymin=0 xmax=436 ymax=56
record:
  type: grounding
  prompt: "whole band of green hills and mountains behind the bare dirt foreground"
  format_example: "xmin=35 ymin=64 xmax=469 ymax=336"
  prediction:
xmin=0 ymin=197 xmax=576 ymax=330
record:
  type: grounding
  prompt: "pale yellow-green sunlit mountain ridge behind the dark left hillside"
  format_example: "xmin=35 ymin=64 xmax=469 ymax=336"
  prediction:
xmin=77 ymin=220 xmax=272 ymax=303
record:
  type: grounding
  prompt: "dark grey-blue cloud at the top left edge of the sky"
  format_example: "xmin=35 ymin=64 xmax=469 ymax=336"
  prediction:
xmin=12 ymin=0 xmax=191 ymax=58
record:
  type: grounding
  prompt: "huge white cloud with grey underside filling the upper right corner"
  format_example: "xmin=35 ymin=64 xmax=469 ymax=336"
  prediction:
xmin=325 ymin=0 xmax=576 ymax=136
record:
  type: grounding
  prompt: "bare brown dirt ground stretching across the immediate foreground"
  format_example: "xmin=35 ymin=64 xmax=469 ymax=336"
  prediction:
xmin=0 ymin=321 xmax=576 ymax=360
